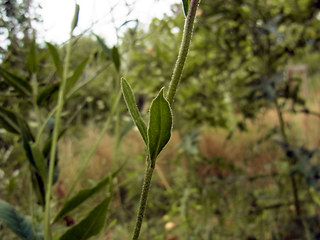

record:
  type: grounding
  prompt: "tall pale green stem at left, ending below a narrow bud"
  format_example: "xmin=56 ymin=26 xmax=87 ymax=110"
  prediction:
xmin=44 ymin=31 xmax=72 ymax=240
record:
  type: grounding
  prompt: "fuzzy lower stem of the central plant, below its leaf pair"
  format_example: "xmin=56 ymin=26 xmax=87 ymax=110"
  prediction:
xmin=132 ymin=159 xmax=154 ymax=240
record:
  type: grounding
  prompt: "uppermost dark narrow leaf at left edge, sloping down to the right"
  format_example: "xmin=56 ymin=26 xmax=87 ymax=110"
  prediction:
xmin=0 ymin=67 xmax=32 ymax=96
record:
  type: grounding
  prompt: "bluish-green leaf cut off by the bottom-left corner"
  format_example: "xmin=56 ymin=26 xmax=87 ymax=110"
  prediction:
xmin=0 ymin=199 xmax=35 ymax=240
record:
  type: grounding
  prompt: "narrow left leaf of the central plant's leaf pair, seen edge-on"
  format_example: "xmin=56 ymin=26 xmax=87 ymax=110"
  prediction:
xmin=121 ymin=78 xmax=148 ymax=145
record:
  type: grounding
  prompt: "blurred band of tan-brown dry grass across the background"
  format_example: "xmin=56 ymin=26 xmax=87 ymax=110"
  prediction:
xmin=59 ymin=86 xmax=320 ymax=197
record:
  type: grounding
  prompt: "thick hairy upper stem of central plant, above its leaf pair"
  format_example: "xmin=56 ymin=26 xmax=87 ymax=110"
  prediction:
xmin=167 ymin=0 xmax=199 ymax=105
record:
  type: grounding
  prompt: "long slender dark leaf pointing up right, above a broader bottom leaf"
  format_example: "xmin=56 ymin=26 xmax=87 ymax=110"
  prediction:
xmin=53 ymin=166 xmax=123 ymax=222
